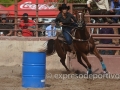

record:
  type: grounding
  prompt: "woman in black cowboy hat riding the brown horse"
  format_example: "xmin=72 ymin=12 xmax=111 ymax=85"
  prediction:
xmin=55 ymin=4 xmax=77 ymax=58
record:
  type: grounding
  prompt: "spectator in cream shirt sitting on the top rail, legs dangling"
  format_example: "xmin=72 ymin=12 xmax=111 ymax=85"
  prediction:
xmin=87 ymin=0 xmax=113 ymax=23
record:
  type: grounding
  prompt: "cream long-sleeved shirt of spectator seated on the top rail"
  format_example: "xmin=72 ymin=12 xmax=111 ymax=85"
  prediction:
xmin=87 ymin=0 xmax=110 ymax=11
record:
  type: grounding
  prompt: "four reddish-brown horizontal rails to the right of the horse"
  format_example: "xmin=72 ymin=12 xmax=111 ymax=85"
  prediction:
xmin=85 ymin=15 xmax=120 ymax=50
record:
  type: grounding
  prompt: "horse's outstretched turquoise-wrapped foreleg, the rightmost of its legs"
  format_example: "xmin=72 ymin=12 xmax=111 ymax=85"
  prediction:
xmin=93 ymin=47 xmax=108 ymax=73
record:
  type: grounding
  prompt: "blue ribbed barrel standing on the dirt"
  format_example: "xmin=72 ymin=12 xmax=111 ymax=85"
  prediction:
xmin=22 ymin=52 xmax=46 ymax=88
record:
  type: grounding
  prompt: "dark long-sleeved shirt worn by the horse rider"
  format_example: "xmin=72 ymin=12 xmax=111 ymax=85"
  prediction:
xmin=55 ymin=12 xmax=77 ymax=24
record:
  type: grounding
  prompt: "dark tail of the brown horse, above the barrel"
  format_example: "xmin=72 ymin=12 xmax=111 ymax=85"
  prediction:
xmin=46 ymin=39 xmax=55 ymax=55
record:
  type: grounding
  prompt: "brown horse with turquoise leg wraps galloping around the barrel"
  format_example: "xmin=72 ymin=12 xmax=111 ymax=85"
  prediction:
xmin=46 ymin=10 xmax=107 ymax=74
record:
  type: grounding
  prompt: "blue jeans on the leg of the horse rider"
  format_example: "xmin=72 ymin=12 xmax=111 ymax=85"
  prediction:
xmin=62 ymin=27 xmax=73 ymax=45
